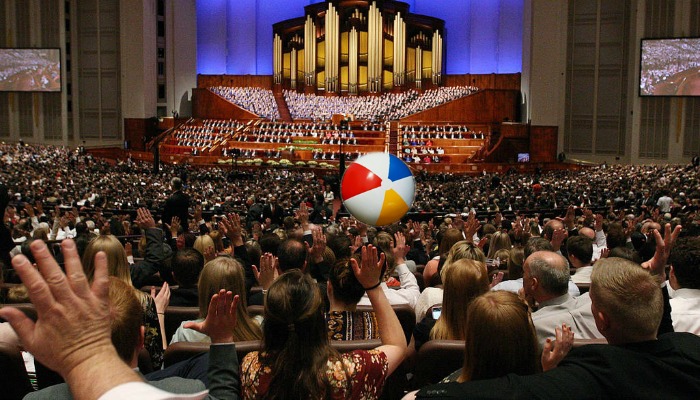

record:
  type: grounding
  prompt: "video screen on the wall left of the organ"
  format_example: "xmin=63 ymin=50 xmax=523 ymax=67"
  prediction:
xmin=0 ymin=49 xmax=61 ymax=92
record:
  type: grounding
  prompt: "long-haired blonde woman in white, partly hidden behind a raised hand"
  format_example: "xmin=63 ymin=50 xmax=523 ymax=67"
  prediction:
xmin=170 ymin=256 xmax=262 ymax=343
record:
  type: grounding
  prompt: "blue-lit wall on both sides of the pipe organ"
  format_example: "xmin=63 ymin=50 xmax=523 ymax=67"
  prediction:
xmin=197 ymin=0 xmax=524 ymax=75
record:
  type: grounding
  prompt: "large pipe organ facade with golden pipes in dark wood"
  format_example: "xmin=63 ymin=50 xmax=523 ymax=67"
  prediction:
xmin=273 ymin=0 xmax=445 ymax=95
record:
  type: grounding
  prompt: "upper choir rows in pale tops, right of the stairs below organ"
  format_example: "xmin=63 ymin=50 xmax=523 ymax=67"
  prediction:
xmin=284 ymin=86 xmax=477 ymax=122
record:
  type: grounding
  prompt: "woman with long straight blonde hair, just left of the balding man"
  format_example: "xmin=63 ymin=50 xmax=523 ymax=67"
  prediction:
xmin=413 ymin=259 xmax=489 ymax=350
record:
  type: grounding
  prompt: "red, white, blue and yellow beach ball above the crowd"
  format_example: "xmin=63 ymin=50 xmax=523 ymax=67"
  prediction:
xmin=340 ymin=153 xmax=416 ymax=226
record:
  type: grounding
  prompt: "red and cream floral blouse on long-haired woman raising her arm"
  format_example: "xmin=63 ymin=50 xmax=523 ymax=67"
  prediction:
xmin=241 ymin=350 xmax=388 ymax=400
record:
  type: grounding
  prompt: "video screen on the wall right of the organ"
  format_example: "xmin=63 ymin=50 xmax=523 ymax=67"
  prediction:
xmin=639 ymin=38 xmax=700 ymax=96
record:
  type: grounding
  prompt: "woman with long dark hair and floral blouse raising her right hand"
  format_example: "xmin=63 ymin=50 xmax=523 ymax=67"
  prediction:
xmin=241 ymin=245 xmax=406 ymax=400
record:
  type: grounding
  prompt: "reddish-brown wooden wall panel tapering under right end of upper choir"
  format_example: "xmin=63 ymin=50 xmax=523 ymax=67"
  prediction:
xmin=400 ymin=89 xmax=519 ymax=123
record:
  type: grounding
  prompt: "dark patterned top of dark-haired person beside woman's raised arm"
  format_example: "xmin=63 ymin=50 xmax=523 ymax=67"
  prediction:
xmin=325 ymin=311 xmax=379 ymax=340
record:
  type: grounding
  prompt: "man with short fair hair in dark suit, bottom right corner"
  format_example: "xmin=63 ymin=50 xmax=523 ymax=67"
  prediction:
xmin=417 ymin=258 xmax=700 ymax=399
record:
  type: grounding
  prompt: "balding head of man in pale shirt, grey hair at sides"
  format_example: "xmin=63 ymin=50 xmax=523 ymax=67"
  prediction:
xmin=523 ymin=251 xmax=570 ymax=301
